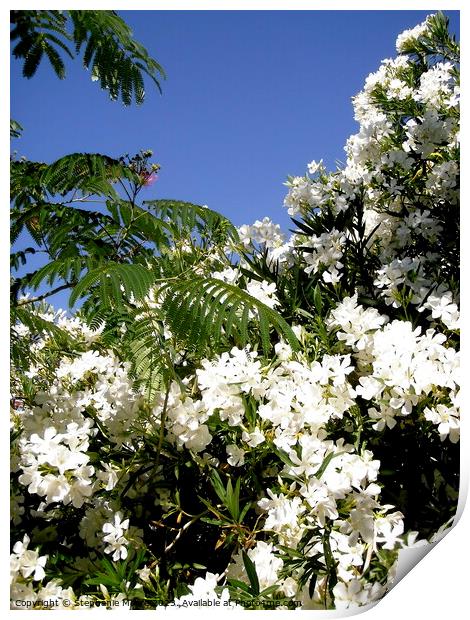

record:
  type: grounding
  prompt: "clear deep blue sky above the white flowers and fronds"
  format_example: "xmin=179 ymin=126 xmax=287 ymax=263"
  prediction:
xmin=11 ymin=11 xmax=458 ymax=306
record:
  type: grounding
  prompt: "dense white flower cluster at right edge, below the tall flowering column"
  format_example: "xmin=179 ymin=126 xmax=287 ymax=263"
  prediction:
xmin=329 ymin=295 xmax=459 ymax=442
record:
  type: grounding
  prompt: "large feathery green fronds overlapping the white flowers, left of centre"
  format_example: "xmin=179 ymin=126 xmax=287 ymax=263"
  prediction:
xmin=11 ymin=148 xmax=298 ymax=394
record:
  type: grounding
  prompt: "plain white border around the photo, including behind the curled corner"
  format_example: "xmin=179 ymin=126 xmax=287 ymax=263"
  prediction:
xmin=0 ymin=0 xmax=470 ymax=620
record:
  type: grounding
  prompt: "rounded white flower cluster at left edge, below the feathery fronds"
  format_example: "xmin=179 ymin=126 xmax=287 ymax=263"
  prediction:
xmin=12 ymin=313 xmax=147 ymax=519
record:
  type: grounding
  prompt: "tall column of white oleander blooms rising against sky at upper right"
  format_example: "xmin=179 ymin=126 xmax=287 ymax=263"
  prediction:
xmin=285 ymin=16 xmax=459 ymax=330
